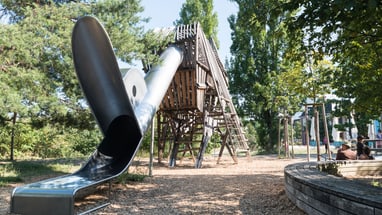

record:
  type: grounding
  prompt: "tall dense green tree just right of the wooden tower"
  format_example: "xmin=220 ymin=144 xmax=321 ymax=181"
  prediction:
xmin=228 ymin=0 xmax=300 ymax=151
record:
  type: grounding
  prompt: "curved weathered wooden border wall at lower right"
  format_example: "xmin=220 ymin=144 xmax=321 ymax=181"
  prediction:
xmin=284 ymin=160 xmax=382 ymax=215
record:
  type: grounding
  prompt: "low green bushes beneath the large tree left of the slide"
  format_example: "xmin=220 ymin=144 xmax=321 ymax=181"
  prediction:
xmin=0 ymin=123 xmax=97 ymax=159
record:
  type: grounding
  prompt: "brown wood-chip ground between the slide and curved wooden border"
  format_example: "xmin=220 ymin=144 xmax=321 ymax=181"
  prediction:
xmin=0 ymin=155 xmax=305 ymax=215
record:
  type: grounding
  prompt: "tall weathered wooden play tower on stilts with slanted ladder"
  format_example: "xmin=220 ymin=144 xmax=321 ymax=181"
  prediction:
xmin=157 ymin=23 xmax=249 ymax=168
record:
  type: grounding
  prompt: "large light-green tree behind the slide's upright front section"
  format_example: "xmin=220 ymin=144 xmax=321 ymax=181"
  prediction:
xmin=0 ymin=0 xmax=157 ymax=156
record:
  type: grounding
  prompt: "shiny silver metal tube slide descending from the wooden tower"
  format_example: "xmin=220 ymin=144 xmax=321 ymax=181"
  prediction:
xmin=11 ymin=16 xmax=182 ymax=215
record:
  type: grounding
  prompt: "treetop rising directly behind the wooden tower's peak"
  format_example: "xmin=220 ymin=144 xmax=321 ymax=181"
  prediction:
xmin=175 ymin=0 xmax=219 ymax=47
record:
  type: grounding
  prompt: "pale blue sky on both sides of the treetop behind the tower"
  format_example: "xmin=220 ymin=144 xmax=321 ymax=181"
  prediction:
xmin=141 ymin=0 xmax=238 ymax=62
